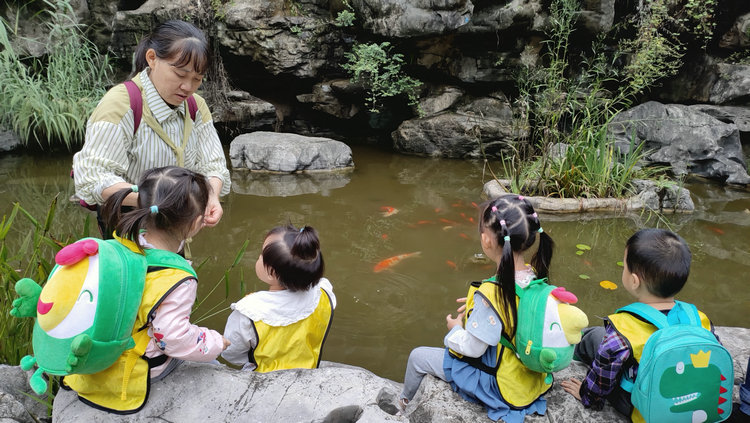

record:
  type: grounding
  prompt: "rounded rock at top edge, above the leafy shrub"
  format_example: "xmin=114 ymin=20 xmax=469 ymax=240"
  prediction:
xmin=352 ymin=0 xmax=474 ymax=38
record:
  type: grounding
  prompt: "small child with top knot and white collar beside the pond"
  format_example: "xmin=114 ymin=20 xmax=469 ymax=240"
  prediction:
xmin=222 ymin=225 xmax=336 ymax=373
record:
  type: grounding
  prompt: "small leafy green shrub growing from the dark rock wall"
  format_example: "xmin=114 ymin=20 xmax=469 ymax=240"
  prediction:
xmin=342 ymin=42 xmax=422 ymax=113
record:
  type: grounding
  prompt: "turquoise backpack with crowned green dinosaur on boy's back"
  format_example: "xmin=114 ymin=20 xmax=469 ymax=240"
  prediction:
xmin=617 ymin=301 xmax=734 ymax=423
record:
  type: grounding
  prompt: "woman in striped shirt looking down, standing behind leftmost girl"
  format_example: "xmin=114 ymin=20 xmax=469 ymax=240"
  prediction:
xmin=73 ymin=20 xmax=231 ymax=238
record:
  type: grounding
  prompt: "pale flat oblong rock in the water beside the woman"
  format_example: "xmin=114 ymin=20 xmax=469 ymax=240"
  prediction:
xmin=229 ymin=131 xmax=354 ymax=173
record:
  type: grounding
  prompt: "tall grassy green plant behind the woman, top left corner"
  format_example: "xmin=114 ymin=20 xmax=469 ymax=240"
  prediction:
xmin=0 ymin=0 xmax=111 ymax=150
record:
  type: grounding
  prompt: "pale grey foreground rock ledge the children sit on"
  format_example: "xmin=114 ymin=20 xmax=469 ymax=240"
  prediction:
xmin=52 ymin=327 xmax=750 ymax=423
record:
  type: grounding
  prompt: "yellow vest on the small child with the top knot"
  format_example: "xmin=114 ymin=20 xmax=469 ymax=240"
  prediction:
xmin=248 ymin=288 xmax=333 ymax=373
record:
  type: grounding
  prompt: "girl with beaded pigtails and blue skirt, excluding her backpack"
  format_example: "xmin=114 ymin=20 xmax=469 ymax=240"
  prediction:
xmin=398 ymin=195 xmax=554 ymax=423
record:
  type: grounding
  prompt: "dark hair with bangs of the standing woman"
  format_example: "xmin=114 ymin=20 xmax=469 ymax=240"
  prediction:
xmin=135 ymin=20 xmax=211 ymax=75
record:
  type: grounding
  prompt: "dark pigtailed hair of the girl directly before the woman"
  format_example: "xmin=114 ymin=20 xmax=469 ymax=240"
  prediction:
xmin=102 ymin=166 xmax=210 ymax=252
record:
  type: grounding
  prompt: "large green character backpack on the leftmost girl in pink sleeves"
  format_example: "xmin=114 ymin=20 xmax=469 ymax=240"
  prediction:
xmin=10 ymin=238 xmax=195 ymax=395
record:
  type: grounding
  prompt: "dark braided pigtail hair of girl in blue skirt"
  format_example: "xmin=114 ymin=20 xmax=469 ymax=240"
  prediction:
xmin=479 ymin=195 xmax=555 ymax=339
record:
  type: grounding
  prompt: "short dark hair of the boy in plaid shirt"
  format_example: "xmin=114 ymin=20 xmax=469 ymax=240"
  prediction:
xmin=625 ymin=229 xmax=691 ymax=298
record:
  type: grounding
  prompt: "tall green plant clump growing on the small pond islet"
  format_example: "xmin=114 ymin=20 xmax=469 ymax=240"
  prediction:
xmin=501 ymin=0 xmax=681 ymax=197
